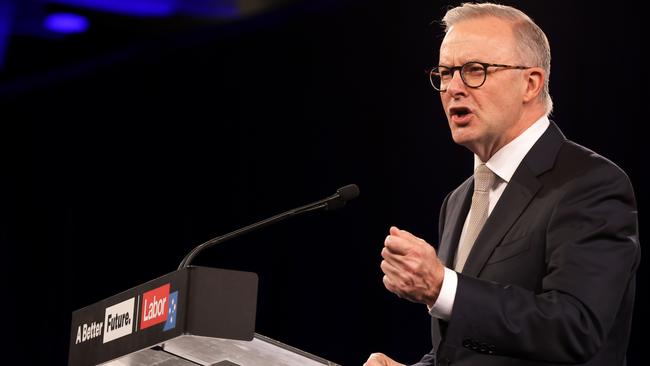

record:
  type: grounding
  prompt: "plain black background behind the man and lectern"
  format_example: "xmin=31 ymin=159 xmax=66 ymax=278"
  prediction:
xmin=0 ymin=0 xmax=650 ymax=365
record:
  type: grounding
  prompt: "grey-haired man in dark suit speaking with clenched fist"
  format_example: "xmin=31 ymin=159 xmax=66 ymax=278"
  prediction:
xmin=364 ymin=3 xmax=640 ymax=366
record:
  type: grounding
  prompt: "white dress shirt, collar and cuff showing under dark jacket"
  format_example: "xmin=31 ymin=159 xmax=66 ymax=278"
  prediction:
xmin=429 ymin=116 xmax=550 ymax=320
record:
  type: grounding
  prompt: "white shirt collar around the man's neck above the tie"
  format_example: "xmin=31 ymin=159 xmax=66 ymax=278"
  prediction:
xmin=474 ymin=116 xmax=550 ymax=183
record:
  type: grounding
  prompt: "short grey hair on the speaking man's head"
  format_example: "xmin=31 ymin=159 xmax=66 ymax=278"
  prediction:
xmin=442 ymin=3 xmax=553 ymax=114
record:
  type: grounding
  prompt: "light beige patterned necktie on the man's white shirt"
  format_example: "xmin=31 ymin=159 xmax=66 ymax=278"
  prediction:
xmin=454 ymin=164 xmax=494 ymax=272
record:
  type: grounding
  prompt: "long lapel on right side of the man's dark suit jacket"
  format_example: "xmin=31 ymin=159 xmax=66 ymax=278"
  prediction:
xmin=456 ymin=122 xmax=565 ymax=277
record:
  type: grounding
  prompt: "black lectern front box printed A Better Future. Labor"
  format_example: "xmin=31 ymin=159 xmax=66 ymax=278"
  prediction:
xmin=68 ymin=267 xmax=257 ymax=366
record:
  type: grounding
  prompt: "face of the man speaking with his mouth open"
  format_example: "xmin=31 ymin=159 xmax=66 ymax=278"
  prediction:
xmin=439 ymin=17 xmax=526 ymax=160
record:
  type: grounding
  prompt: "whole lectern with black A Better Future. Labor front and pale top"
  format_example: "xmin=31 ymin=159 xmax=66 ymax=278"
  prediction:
xmin=69 ymin=266 xmax=336 ymax=366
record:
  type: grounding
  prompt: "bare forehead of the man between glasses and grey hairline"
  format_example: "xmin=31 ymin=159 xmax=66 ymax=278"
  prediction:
xmin=440 ymin=17 xmax=516 ymax=65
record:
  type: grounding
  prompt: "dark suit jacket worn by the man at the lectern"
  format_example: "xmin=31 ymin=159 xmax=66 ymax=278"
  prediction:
xmin=416 ymin=122 xmax=640 ymax=366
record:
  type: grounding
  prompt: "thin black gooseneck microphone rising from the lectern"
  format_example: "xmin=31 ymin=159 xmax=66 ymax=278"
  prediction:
xmin=178 ymin=184 xmax=359 ymax=270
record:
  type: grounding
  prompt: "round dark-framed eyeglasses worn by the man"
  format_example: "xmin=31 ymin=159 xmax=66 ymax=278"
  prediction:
xmin=429 ymin=61 xmax=531 ymax=92
